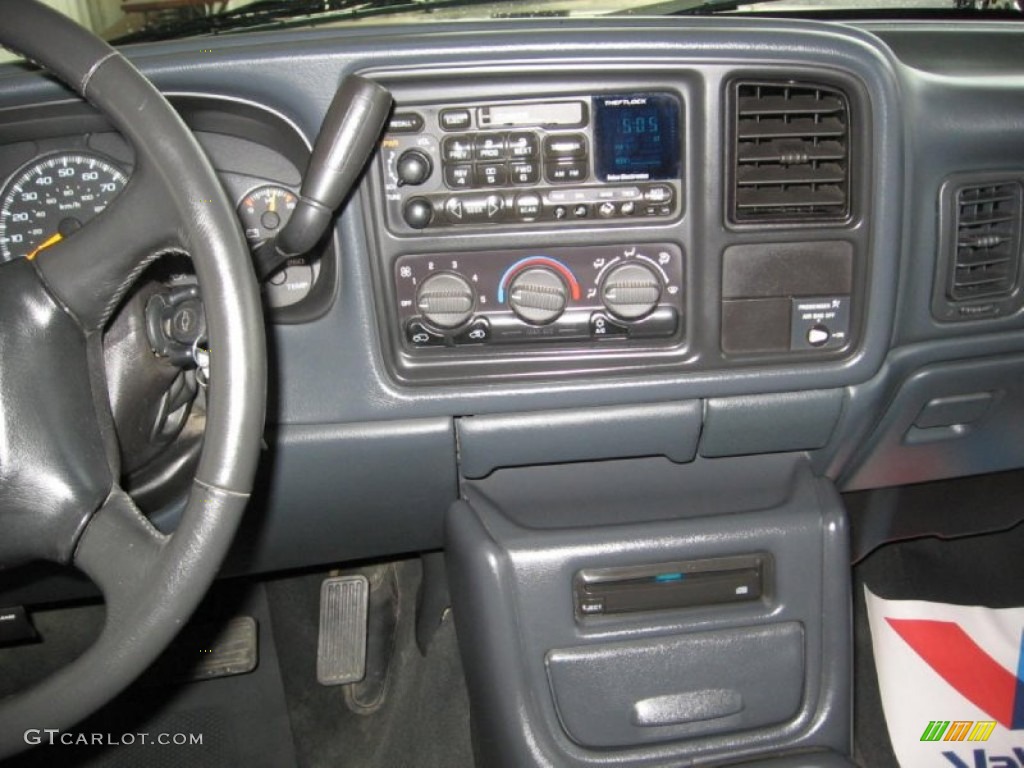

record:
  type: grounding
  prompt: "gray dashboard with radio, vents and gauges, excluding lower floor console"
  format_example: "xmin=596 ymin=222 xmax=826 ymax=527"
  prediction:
xmin=0 ymin=17 xmax=1024 ymax=571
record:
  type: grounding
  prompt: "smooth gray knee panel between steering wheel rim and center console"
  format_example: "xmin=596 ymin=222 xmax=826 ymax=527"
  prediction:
xmin=225 ymin=419 xmax=458 ymax=573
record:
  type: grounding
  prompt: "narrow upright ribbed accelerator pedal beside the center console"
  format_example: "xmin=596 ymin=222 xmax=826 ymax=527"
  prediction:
xmin=316 ymin=574 xmax=370 ymax=685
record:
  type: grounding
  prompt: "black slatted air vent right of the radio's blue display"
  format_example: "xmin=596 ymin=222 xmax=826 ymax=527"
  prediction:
xmin=731 ymin=82 xmax=850 ymax=223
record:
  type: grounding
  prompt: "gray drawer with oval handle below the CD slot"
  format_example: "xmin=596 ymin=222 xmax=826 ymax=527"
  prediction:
xmin=546 ymin=622 xmax=804 ymax=746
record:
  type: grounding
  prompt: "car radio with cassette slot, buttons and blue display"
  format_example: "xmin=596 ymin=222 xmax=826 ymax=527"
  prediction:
xmin=380 ymin=92 xmax=684 ymax=234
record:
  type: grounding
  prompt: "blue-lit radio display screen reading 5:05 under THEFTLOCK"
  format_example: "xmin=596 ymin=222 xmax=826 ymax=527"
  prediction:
xmin=594 ymin=93 xmax=680 ymax=181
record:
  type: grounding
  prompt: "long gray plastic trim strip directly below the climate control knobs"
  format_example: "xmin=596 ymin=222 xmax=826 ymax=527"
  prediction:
xmin=456 ymin=401 xmax=701 ymax=478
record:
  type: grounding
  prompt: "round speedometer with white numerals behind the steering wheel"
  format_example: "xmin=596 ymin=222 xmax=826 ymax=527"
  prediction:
xmin=0 ymin=153 xmax=128 ymax=261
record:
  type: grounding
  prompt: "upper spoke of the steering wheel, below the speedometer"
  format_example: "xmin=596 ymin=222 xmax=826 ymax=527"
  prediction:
xmin=35 ymin=163 xmax=182 ymax=331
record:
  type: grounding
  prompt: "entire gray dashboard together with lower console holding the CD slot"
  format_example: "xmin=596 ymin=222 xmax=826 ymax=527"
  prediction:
xmin=0 ymin=14 xmax=1024 ymax=768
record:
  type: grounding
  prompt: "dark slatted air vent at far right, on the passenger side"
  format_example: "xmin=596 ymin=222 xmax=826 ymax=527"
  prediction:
xmin=948 ymin=181 xmax=1021 ymax=301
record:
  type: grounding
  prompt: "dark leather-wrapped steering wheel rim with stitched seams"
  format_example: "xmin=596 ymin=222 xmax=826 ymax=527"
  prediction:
xmin=0 ymin=0 xmax=266 ymax=759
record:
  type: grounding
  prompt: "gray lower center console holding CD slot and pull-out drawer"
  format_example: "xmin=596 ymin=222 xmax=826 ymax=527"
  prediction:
xmin=445 ymin=454 xmax=852 ymax=768
